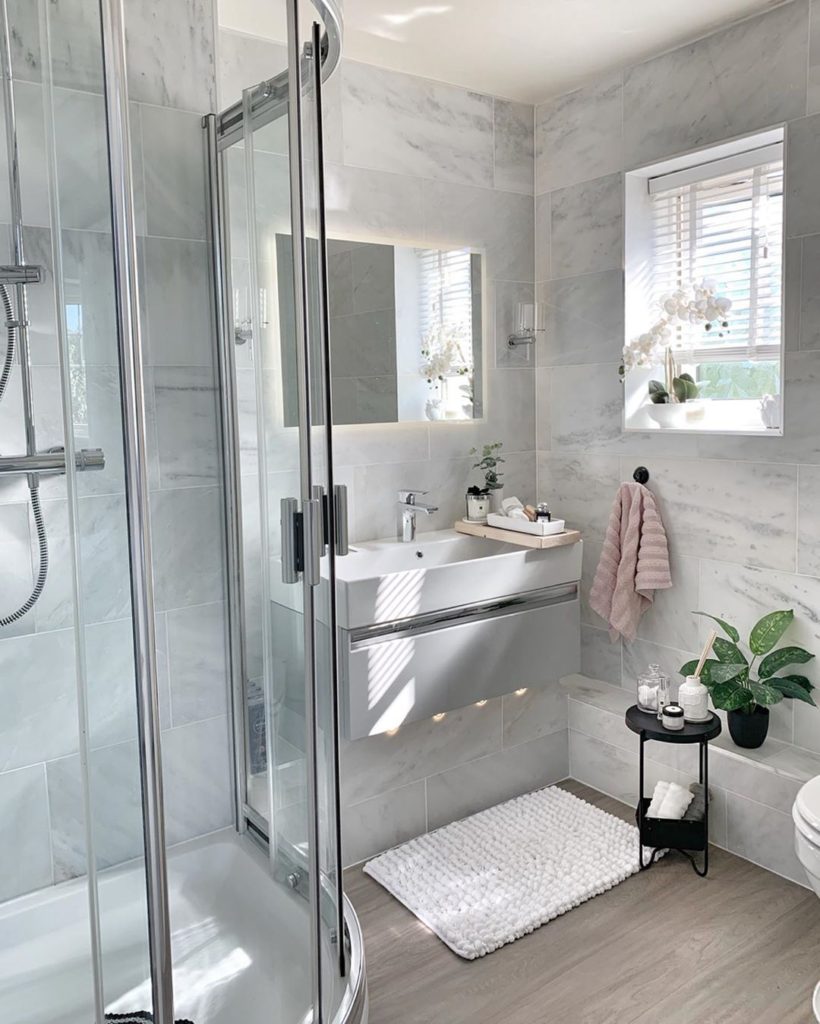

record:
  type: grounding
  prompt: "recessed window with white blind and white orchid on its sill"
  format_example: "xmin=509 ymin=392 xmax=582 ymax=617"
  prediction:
xmin=623 ymin=128 xmax=784 ymax=434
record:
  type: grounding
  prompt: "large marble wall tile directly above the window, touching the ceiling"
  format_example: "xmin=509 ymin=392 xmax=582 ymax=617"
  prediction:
xmin=623 ymin=0 xmax=809 ymax=167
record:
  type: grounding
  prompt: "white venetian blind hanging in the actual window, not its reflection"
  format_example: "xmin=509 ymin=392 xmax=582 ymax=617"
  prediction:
xmin=649 ymin=144 xmax=783 ymax=362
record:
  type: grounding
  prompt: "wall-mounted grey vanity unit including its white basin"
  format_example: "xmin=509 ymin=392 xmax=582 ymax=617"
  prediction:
xmin=338 ymin=530 xmax=582 ymax=739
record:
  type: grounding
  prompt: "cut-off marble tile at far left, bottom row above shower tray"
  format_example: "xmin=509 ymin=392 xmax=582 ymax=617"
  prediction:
xmin=0 ymin=765 xmax=52 ymax=900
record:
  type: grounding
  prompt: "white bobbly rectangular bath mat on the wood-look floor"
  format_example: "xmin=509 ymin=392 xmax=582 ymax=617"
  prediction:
xmin=364 ymin=786 xmax=639 ymax=959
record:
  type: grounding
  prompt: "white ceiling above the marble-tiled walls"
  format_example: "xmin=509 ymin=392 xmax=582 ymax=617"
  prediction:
xmin=219 ymin=0 xmax=780 ymax=102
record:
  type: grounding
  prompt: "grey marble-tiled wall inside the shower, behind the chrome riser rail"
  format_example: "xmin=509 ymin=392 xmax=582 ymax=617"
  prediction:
xmin=0 ymin=0 xmax=231 ymax=898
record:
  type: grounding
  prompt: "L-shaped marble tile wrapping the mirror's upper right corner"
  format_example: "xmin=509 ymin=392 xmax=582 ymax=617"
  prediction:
xmin=424 ymin=181 xmax=534 ymax=282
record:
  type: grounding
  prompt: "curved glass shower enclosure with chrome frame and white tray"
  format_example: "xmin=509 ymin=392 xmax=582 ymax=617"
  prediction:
xmin=0 ymin=0 xmax=366 ymax=1024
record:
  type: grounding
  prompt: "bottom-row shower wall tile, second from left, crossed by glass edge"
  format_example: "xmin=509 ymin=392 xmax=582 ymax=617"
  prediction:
xmin=46 ymin=741 xmax=143 ymax=882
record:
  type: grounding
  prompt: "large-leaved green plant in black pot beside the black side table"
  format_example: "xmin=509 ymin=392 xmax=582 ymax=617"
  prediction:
xmin=681 ymin=608 xmax=816 ymax=749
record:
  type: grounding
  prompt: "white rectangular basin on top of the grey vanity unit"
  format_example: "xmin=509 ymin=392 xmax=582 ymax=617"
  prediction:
xmin=336 ymin=529 xmax=582 ymax=630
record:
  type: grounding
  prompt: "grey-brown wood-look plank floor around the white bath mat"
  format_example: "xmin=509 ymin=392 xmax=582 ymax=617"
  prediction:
xmin=346 ymin=781 xmax=820 ymax=1024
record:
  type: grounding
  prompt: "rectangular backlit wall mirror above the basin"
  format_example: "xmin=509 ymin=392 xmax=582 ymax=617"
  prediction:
xmin=276 ymin=234 xmax=483 ymax=426
